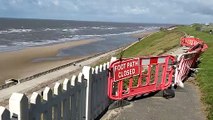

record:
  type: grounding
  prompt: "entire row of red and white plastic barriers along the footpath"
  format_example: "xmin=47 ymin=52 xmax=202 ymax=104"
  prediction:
xmin=108 ymin=37 xmax=208 ymax=100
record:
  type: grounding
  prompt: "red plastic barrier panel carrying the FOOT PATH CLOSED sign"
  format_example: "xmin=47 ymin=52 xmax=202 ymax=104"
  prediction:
xmin=108 ymin=56 xmax=175 ymax=100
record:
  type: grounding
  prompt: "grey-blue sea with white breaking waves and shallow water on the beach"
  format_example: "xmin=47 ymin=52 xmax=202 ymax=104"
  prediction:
xmin=0 ymin=18 xmax=171 ymax=57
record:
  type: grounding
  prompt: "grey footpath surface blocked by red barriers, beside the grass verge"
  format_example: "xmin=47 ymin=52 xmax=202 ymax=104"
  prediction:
xmin=101 ymin=47 xmax=206 ymax=120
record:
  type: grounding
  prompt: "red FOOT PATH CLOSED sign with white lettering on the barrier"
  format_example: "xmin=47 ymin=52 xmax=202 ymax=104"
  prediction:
xmin=113 ymin=58 xmax=140 ymax=81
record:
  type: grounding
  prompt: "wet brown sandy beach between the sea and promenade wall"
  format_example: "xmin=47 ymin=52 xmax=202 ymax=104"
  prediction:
xmin=0 ymin=39 xmax=97 ymax=84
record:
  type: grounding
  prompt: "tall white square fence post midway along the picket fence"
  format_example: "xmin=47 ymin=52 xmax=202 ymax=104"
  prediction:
xmin=82 ymin=66 xmax=92 ymax=120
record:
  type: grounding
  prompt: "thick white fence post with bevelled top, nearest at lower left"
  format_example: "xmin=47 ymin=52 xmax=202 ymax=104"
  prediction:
xmin=9 ymin=93 xmax=29 ymax=120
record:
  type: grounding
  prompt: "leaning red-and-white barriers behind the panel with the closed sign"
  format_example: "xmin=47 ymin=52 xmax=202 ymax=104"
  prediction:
xmin=175 ymin=37 xmax=208 ymax=87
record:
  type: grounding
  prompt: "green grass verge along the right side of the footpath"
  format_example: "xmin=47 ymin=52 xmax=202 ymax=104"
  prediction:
xmin=178 ymin=26 xmax=213 ymax=120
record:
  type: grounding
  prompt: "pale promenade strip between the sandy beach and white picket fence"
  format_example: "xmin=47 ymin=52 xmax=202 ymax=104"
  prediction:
xmin=0 ymin=30 xmax=157 ymax=107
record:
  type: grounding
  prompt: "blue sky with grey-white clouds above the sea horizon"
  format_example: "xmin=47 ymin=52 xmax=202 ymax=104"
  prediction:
xmin=0 ymin=0 xmax=213 ymax=24
